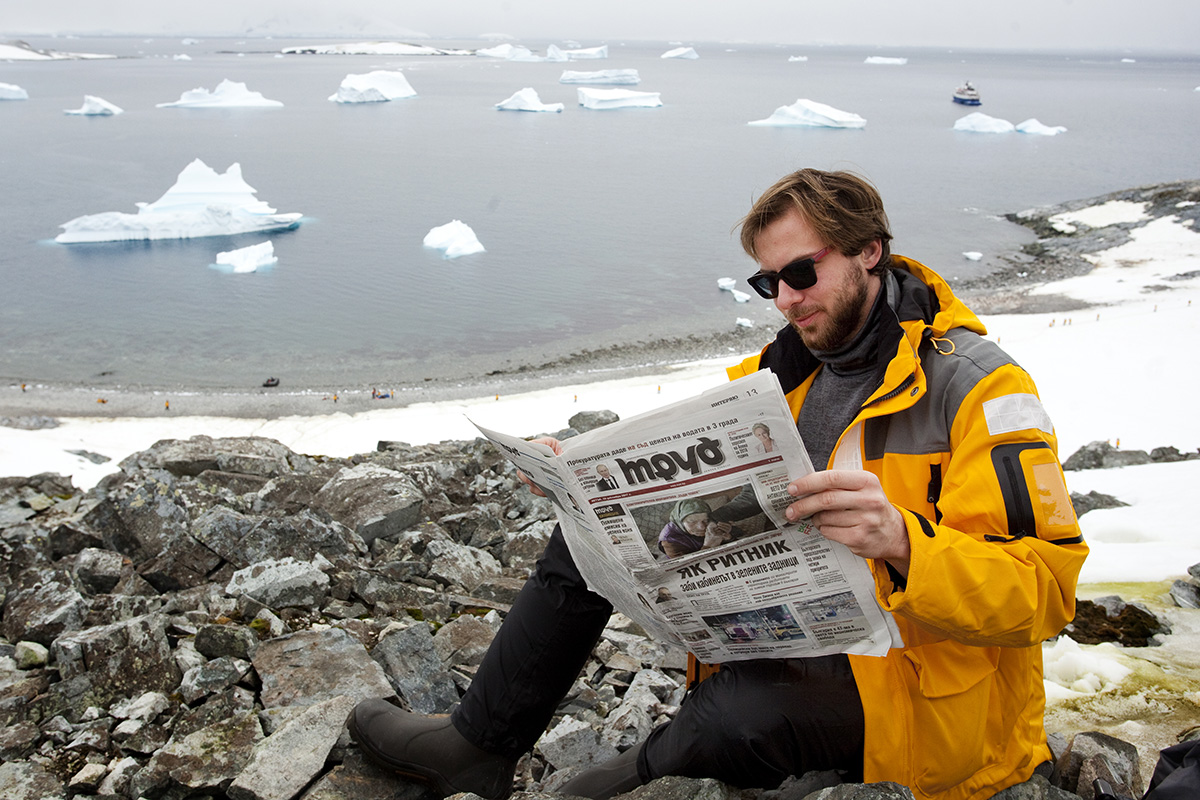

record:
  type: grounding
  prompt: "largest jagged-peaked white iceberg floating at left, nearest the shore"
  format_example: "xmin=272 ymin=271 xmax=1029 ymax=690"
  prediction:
xmin=54 ymin=158 xmax=301 ymax=245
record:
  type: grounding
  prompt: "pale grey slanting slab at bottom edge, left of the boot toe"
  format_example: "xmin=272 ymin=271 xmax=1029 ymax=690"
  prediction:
xmin=228 ymin=697 xmax=358 ymax=800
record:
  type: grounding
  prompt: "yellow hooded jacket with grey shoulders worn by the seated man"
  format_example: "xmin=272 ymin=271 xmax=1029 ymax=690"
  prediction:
xmin=728 ymin=255 xmax=1087 ymax=800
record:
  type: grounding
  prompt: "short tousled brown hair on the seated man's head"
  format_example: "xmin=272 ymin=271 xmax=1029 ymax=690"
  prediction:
xmin=739 ymin=169 xmax=892 ymax=275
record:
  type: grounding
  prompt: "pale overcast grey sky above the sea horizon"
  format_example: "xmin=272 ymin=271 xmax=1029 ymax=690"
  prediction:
xmin=7 ymin=0 xmax=1200 ymax=54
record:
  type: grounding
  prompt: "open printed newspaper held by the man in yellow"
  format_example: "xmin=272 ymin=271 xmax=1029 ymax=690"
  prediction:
xmin=476 ymin=369 xmax=901 ymax=662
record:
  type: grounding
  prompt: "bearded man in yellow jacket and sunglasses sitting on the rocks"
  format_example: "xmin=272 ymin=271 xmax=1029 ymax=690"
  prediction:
xmin=349 ymin=169 xmax=1087 ymax=800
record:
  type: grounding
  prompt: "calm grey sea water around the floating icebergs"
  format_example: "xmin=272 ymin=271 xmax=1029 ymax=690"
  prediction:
xmin=0 ymin=38 xmax=1200 ymax=389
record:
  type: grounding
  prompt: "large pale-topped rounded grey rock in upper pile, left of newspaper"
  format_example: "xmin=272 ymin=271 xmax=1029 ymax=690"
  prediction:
xmin=314 ymin=464 xmax=425 ymax=545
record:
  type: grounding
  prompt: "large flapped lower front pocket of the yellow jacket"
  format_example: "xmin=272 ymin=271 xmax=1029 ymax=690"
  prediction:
xmin=904 ymin=642 xmax=997 ymax=794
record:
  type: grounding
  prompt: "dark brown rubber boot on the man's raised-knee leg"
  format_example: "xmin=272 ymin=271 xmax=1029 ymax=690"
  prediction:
xmin=347 ymin=700 xmax=517 ymax=800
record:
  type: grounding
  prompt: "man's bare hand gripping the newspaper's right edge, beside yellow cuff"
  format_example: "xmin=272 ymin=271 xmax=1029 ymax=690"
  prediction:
xmin=787 ymin=470 xmax=911 ymax=576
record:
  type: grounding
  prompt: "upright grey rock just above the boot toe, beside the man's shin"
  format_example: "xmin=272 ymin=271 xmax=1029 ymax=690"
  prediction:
xmin=371 ymin=622 xmax=458 ymax=714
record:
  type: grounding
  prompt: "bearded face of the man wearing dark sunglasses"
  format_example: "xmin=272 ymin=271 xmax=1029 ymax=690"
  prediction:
xmin=755 ymin=209 xmax=882 ymax=350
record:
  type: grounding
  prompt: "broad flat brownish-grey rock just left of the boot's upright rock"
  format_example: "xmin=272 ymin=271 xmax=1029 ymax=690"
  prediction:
xmin=253 ymin=628 xmax=392 ymax=709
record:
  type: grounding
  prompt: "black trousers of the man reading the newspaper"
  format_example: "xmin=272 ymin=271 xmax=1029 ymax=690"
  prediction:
xmin=451 ymin=528 xmax=863 ymax=788
